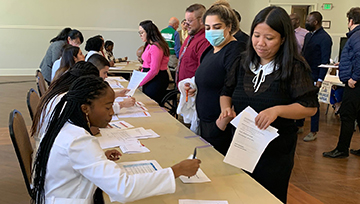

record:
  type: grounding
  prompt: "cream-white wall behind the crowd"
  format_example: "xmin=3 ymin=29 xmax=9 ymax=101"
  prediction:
xmin=0 ymin=0 xmax=358 ymax=75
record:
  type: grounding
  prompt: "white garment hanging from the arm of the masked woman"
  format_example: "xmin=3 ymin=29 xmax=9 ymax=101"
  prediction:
xmin=176 ymin=77 xmax=199 ymax=134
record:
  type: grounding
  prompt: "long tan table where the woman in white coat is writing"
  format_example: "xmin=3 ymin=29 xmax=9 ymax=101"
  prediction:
xmin=104 ymin=79 xmax=281 ymax=204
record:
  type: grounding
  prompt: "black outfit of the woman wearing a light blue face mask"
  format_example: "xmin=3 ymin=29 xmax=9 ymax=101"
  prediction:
xmin=195 ymin=41 xmax=245 ymax=155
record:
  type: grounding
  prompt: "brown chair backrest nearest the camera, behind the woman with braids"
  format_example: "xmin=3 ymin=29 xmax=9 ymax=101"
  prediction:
xmin=9 ymin=109 xmax=33 ymax=197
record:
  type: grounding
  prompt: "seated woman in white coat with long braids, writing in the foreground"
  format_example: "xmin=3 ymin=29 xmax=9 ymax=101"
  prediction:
xmin=33 ymin=76 xmax=200 ymax=204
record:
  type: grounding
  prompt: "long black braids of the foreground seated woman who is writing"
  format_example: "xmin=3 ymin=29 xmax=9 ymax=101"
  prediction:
xmin=32 ymin=76 xmax=109 ymax=204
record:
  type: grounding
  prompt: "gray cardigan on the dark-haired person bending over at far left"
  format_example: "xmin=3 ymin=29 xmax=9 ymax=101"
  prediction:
xmin=40 ymin=40 xmax=67 ymax=82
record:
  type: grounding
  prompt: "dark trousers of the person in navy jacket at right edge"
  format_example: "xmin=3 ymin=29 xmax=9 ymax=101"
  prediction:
xmin=336 ymin=83 xmax=360 ymax=151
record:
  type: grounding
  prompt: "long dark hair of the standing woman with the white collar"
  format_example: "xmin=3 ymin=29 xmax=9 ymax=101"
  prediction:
xmin=243 ymin=6 xmax=308 ymax=81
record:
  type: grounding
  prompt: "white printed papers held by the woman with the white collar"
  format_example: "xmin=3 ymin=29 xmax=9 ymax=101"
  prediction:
xmin=224 ymin=106 xmax=279 ymax=173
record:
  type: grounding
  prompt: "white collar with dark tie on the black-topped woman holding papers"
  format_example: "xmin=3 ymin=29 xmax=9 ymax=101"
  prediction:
xmin=250 ymin=60 xmax=279 ymax=93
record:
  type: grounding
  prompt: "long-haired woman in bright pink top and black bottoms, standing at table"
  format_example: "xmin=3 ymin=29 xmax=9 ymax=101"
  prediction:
xmin=139 ymin=20 xmax=170 ymax=105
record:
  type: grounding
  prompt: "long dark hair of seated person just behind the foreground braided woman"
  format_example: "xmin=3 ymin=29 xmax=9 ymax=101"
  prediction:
xmin=31 ymin=61 xmax=99 ymax=136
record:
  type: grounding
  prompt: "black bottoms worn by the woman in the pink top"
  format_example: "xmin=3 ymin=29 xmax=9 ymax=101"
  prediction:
xmin=143 ymin=68 xmax=169 ymax=105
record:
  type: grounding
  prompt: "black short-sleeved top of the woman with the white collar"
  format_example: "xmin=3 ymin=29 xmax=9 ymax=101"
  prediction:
xmin=222 ymin=57 xmax=319 ymax=137
